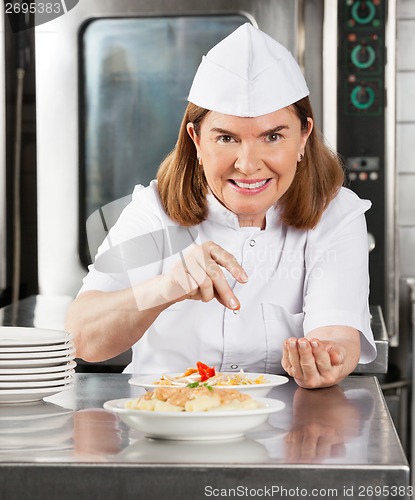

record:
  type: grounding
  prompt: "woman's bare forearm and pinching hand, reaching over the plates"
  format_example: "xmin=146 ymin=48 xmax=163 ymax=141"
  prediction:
xmin=65 ymin=242 xmax=248 ymax=362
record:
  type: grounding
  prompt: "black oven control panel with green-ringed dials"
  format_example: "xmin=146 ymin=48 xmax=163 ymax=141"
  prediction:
xmin=337 ymin=0 xmax=387 ymax=307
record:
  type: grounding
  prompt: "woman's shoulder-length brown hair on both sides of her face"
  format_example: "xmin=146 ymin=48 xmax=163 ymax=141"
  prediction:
xmin=157 ymin=97 xmax=344 ymax=229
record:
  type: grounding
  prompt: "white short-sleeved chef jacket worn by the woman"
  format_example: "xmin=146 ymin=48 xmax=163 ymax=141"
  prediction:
xmin=80 ymin=181 xmax=376 ymax=374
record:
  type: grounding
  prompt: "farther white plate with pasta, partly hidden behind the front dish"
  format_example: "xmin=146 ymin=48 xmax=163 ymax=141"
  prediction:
xmin=128 ymin=370 xmax=288 ymax=397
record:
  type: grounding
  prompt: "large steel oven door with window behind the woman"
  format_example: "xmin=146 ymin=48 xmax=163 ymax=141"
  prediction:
xmin=35 ymin=0 xmax=324 ymax=296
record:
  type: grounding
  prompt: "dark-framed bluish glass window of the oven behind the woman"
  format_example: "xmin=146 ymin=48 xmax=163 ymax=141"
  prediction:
xmin=80 ymin=15 xmax=248 ymax=264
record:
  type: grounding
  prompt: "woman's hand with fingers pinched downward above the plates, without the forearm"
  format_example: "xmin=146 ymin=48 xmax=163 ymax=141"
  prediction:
xmin=159 ymin=241 xmax=248 ymax=310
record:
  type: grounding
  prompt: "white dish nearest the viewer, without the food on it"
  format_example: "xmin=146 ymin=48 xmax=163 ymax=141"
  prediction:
xmin=104 ymin=398 xmax=285 ymax=441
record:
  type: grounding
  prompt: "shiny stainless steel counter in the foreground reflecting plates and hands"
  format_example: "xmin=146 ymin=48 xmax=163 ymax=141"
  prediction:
xmin=0 ymin=373 xmax=411 ymax=500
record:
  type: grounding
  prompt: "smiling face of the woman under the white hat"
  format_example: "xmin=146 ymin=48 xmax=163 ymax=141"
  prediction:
xmin=187 ymin=108 xmax=313 ymax=228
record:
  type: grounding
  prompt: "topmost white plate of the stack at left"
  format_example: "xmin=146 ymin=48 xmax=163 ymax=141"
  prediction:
xmin=0 ymin=326 xmax=73 ymax=347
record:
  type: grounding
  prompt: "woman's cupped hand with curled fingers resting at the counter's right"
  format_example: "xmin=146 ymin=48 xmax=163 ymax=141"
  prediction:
xmin=281 ymin=337 xmax=348 ymax=389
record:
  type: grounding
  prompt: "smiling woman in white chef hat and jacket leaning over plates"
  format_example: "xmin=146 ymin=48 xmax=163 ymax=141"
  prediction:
xmin=66 ymin=24 xmax=376 ymax=388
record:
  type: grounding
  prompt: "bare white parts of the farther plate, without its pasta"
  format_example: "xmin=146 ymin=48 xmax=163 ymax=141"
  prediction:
xmin=128 ymin=372 xmax=288 ymax=398
